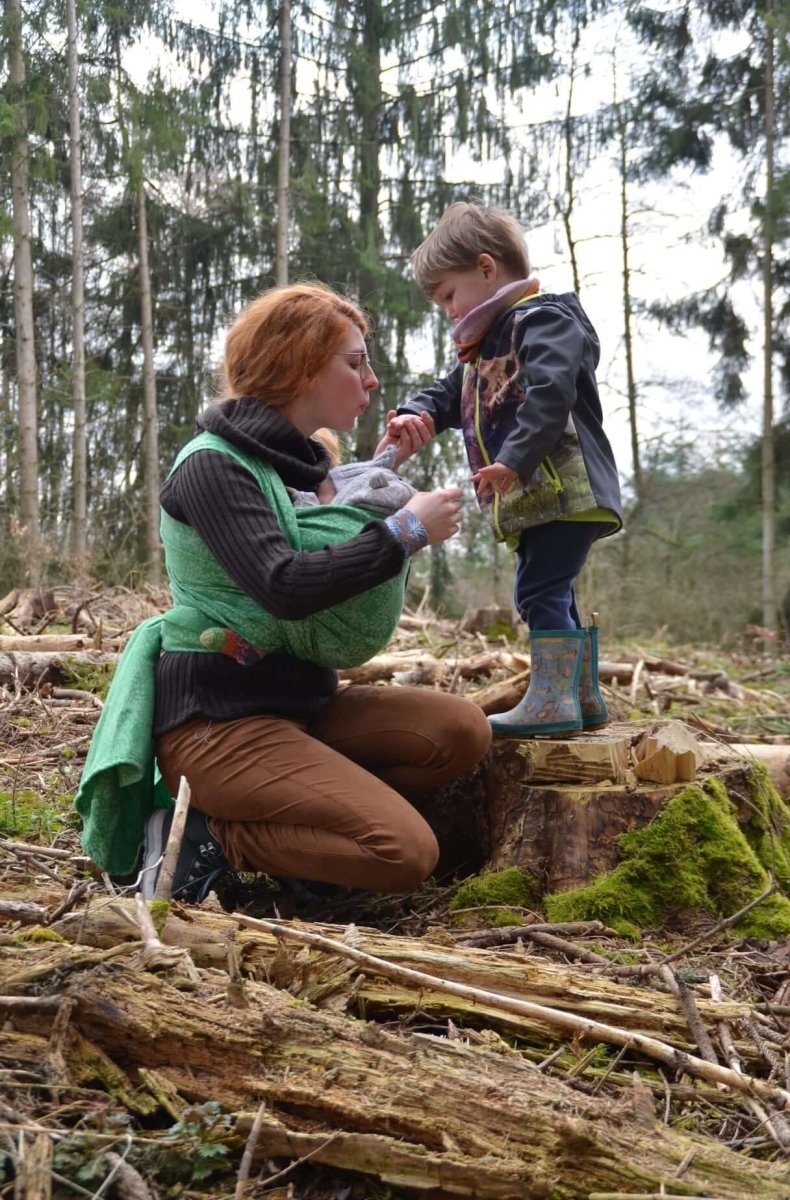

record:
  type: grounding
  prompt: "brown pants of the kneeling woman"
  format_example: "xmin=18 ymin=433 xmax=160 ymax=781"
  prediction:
xmin=156 ymin=685 xmax=491 ymax=892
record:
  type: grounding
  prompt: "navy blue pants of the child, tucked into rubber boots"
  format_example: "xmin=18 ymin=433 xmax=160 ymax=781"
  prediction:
xmin=514 ymin=521 xmax=611 ymax=631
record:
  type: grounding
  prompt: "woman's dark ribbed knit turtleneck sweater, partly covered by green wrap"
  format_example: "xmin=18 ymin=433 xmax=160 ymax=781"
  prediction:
xmin=154 ymin=398 xmax=403 ymax=736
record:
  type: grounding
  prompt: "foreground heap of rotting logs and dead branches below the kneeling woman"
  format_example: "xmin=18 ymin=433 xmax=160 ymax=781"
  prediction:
xmin=0 ymin=841 xmax=790 ymax=1200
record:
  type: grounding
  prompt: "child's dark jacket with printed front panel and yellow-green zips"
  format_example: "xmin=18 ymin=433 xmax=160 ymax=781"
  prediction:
xmin=401 ymin=293 xmax=622 ymax=540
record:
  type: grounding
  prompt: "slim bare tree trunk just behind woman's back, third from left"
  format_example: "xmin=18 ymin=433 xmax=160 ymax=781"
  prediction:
xmin=137 ymin=172 xmax=162 ymax=583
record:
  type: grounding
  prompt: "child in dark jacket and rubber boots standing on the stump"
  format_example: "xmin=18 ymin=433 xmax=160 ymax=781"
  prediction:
xmin=382 ymin=203 xmax=622 ymax=737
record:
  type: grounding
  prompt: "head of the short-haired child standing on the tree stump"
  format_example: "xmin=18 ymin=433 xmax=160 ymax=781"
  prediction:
xmin=412 ymin=200 xmax=529 ymax=322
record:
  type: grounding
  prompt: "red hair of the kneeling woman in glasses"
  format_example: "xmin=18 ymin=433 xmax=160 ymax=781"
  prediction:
xmin=223 ymin=283 xmax=367 ymax=408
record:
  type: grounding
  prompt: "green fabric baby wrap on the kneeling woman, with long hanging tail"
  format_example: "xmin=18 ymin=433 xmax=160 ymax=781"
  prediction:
xmin=74 ymin=432 xmax=408 ymax=875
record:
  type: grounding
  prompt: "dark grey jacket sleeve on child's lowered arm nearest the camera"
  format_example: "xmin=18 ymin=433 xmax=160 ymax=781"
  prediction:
xmin=497 ymin=305 xmax=585 ymax=484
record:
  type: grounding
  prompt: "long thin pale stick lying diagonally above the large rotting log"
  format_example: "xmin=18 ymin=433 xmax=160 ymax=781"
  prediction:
xmin=233 ymin=913 xmax=790 ymax=1109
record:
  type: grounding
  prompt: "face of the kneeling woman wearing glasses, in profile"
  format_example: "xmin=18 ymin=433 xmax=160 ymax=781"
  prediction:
xmin=283 ymin=325 xmax=378 ymax=437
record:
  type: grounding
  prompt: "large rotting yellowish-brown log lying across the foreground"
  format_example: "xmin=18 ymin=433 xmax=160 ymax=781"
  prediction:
xmin=0 ymin=916 xmax=790 ymax=1200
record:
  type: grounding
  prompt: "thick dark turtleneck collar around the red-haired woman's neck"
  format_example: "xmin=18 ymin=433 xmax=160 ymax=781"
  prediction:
xmin=197 ymin=396 xmax=330 ymax=491
